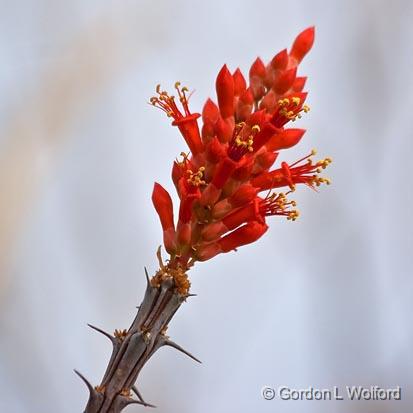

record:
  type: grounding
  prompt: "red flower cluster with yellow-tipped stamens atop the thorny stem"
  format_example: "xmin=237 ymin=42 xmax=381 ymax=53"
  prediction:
xmin=151 ymin=27 xmax=331 ymax=271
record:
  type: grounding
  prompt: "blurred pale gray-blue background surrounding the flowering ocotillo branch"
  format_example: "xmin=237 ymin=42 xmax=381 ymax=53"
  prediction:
xmin=0 ymin=0 xmax=413 ymax=413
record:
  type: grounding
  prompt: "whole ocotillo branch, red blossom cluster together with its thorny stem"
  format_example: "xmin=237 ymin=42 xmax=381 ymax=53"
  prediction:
xmin=78 ymin=28 xmax=331 ymax=413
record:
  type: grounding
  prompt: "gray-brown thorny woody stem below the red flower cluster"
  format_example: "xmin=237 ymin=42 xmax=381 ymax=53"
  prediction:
xmin=75 ymin=269 xmax=200 ymax=413
